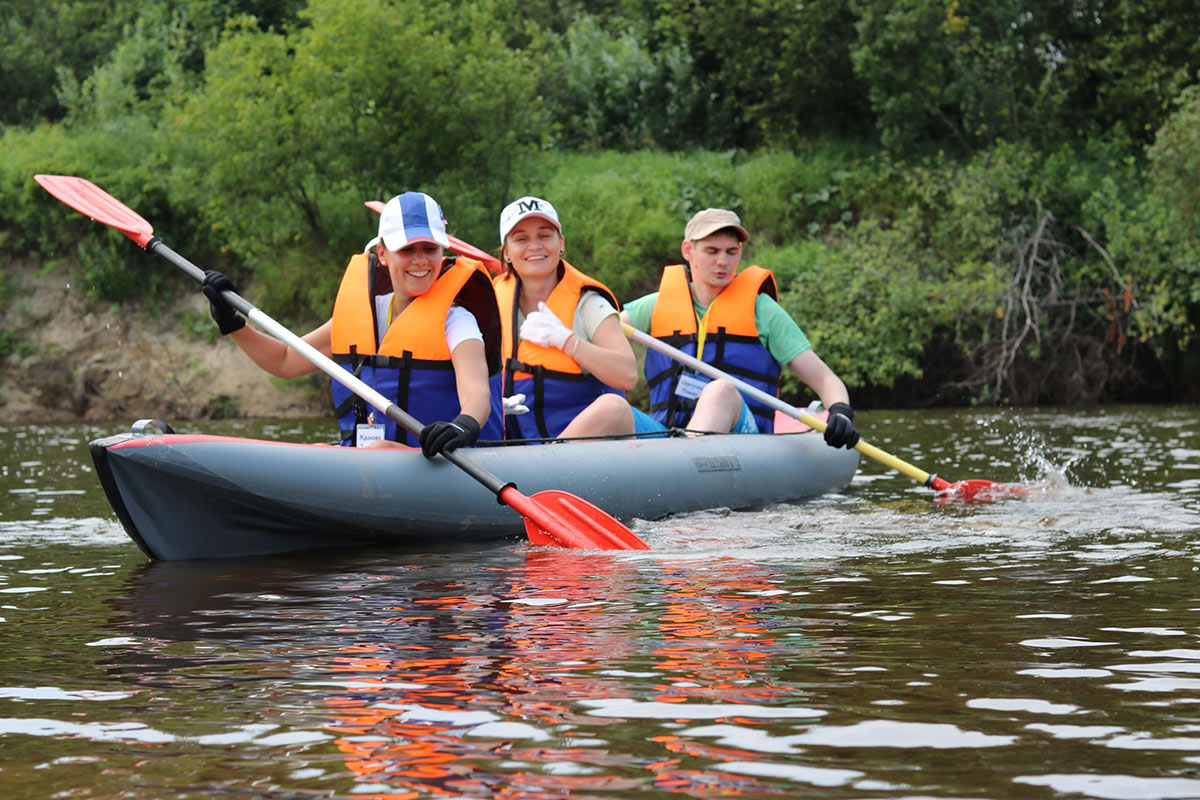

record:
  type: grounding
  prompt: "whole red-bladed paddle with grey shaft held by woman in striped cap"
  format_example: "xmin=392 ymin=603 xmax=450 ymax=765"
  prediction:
xmin=34 ymin=175 xmax=649 ymax=551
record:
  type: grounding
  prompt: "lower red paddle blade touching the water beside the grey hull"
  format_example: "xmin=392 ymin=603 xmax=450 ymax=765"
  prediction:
xmin=500 ymin=486 xmax=650 ymax=551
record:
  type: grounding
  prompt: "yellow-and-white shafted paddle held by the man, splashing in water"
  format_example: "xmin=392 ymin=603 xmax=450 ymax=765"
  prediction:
xmin=620 ymin=323 xmax=1028 ymax=500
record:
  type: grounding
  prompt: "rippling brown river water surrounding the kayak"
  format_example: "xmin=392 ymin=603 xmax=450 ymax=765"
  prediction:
xmin=0 ymin=407 xmax=1200 ymax=800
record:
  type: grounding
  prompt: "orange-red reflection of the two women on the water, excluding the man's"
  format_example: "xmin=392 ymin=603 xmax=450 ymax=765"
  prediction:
xmin=328 ymin=552 xmax=641 ymax=800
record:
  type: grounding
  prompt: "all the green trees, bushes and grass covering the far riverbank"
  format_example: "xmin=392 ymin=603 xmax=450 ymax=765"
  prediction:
xmin=0 ymin=0 xmax=1200 ymax=417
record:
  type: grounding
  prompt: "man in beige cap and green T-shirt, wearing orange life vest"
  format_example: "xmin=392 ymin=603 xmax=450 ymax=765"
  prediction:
xmin=620 ymin=209 xmax=858 ymax=447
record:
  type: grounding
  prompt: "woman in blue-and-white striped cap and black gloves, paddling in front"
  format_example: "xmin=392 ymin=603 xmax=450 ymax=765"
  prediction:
xmin=204 ymin=192 xmax=500 ymax=458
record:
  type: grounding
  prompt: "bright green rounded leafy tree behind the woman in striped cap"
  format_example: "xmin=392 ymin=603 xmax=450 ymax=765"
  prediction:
xmin=170 ymin=0 xmax=542 ymax=316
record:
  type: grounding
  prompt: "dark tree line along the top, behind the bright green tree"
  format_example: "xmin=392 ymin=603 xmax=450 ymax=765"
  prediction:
xmin=0 ymin=0 xmax=1200 ymax=156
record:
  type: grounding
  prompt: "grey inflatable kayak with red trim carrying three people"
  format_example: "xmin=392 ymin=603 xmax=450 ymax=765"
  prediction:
xmin=91 ymin=423 xmax=858 ymax=559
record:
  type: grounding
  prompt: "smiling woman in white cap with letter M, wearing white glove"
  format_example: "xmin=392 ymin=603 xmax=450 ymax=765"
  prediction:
xmin=492 ymin=197 xmax=637 ymax=439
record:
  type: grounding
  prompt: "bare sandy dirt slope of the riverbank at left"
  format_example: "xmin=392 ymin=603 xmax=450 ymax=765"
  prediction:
xmin=0 ymin=263 xmax=330 ymax=425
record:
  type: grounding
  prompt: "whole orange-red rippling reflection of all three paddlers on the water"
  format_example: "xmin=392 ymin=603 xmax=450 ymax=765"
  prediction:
xmin=328 ymin=549 xmax=820 ymax=800
